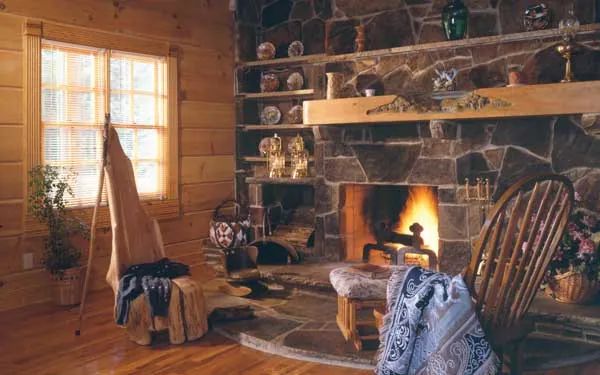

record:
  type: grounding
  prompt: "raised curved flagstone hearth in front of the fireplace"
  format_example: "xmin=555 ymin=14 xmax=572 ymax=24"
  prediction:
xmin=206 ymin=262 xmax=600 ymax=371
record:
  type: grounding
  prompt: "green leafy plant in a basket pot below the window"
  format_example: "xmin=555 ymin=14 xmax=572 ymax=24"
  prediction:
xmin=28 ymin=165 xmax=89 ymax=306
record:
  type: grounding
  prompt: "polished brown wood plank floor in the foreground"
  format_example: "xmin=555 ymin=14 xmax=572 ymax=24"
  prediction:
xmin=0 ymin=293 xmax=600 ymax=375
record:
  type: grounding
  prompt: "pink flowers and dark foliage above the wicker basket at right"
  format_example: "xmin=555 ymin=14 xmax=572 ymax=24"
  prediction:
xmin=546 ymin=193 xmax=600 ymax=281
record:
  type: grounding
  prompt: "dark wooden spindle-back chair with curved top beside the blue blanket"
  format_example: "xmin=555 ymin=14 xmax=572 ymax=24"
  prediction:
xmin=463 ymin=174 xmax=574 ymax=374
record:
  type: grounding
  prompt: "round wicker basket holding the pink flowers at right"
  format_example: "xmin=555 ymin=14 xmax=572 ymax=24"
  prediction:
xmin=546 ymin=272 xmax=599 ymax=304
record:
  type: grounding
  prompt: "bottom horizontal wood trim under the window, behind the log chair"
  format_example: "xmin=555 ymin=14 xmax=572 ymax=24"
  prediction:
xmin=25 ymin=199 xmax=181 ymax=235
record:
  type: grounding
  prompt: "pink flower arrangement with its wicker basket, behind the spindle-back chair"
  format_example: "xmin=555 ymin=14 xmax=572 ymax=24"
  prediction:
xmin=545 ymin=194 xmax=600 ymax=304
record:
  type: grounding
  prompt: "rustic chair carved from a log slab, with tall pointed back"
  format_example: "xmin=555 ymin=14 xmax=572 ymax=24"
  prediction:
xmin=105 ymin=127 xmax=208 ymax=345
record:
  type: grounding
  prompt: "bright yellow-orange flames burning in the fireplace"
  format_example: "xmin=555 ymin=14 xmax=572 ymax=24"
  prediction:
xmin=394 ymin=186 xmax=440 ymax=254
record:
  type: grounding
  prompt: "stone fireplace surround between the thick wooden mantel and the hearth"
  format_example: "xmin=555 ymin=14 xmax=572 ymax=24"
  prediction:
xmin=314 ymin=116 xmax=600 ymax=273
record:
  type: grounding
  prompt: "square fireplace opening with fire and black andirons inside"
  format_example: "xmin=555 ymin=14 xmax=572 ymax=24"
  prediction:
xmin=340 ymin=184 xmax=439 ymax=264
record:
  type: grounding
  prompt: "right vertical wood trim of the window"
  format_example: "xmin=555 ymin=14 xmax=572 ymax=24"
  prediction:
xmin=167 ymin=46 xmax=181 ymax=199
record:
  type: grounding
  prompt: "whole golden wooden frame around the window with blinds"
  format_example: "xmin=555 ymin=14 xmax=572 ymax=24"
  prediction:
xmin=23 ymin=20 xmax=182 ymax=232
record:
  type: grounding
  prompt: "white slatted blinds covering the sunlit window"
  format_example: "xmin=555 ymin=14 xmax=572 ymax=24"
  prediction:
xmin=42 ymin=40 xmax=168 ymax=206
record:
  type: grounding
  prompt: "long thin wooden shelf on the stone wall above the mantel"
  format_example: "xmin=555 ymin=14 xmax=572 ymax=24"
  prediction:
xmin=238 ymin=23 xmax=600 ymax=68
